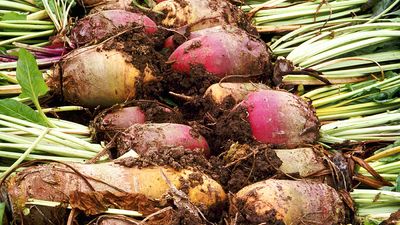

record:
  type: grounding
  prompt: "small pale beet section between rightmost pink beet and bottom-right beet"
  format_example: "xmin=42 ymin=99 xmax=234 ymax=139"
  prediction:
xmin=275 ymin=148 xmax=327 ymax=178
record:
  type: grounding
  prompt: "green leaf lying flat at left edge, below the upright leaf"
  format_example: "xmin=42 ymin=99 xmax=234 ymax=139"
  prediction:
xmin=0 ymin=99 xmax=46 ymax=126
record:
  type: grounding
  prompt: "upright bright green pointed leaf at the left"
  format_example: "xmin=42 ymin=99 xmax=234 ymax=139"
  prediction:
xmin=17 ymin=49 xmax=49 ymax=102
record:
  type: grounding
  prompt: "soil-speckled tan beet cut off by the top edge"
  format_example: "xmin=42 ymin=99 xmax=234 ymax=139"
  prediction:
xmin=153 ymin=0 xmax=248 ymax=30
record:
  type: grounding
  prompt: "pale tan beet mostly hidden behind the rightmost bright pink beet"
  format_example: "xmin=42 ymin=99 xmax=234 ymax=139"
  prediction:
xmin=204 ymin=83 xmax=270 ymax=105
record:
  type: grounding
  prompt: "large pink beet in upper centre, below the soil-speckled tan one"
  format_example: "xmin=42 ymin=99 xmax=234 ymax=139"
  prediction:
xmin=169 ymin=27 xmax=270 ymax=77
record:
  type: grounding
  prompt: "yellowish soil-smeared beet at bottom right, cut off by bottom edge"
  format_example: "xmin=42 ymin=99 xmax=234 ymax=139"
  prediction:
xmin=229 ymin=179 xmax=345 ymax=224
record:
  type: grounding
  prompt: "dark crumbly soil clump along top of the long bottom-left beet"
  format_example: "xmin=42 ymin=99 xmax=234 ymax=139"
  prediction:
xmin=115 ymin=144 xmax=282 ymax=193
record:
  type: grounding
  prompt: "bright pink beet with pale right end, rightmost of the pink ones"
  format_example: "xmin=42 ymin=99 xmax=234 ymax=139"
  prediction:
xmin=236 ymin=90 xmax=319 ymax=148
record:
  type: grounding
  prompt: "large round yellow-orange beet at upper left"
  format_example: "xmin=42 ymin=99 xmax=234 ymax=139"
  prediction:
xmin=48 ymin=40 xmax=157 ymax=107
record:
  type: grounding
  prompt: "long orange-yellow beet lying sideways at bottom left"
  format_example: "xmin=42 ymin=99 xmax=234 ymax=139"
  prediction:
xmin=6 ymin=163 xmax=226 ymax=225
